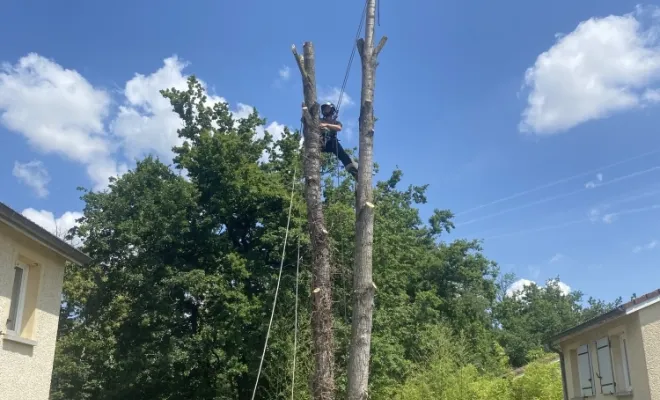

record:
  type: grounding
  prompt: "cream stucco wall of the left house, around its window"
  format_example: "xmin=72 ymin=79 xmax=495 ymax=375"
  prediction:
xmin=0 ymin=223 xmax=64 ymax=400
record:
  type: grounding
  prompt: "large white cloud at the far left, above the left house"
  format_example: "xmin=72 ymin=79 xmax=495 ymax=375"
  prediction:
xmin=0 ymin=53 xmax=124 ymax=189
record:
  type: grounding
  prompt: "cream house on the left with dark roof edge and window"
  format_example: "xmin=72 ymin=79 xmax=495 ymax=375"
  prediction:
xmin=0 ymin=203 xmax=89 ymax=400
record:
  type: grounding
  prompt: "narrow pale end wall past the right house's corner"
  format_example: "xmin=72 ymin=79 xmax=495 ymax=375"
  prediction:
xmin=639 ymin=303 xmax=660 ymax=400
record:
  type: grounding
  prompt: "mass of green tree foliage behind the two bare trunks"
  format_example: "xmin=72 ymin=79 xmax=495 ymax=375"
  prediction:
xmin=52 ymin=77 xmax=610 ymax=400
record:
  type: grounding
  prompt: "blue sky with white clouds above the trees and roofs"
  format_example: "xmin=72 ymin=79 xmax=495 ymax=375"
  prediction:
xmin=0 ymin=0 xmax=660 ymax=299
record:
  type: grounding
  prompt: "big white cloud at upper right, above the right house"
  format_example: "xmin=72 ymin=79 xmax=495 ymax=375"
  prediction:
xmin=519 ymin=8 xmax=660 ymax=135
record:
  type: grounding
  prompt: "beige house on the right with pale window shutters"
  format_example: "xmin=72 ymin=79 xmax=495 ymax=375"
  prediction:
xmin=551 ymin=290 xmax=660 ymax=400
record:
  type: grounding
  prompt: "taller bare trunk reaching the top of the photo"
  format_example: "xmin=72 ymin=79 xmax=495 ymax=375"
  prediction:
xmin=347 ymin=0 xmax=387 ymax=400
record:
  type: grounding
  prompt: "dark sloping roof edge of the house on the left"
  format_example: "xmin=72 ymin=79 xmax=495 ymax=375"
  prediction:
xmin=0 ymin=202 xmax=92 ymax=265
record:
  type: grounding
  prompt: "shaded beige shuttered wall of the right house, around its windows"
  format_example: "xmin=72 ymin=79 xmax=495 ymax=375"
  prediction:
xmin=561 ymin=313 xmax=648 ymax=400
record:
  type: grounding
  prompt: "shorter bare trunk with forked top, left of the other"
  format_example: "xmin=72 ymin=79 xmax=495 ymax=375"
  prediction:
xmin=291 ymin=42 xmax=335 ymax=400
